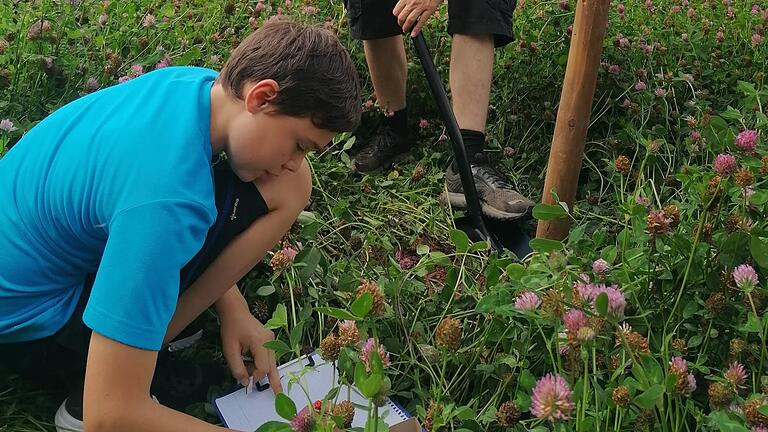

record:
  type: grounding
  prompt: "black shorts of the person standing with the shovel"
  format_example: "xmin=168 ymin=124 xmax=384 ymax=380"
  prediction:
xmin=344 ymin=0 xmax=517 ymax=47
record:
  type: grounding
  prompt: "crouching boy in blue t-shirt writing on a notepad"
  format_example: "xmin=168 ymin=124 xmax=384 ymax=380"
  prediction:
xmin=0 ymin=20 xmax=361 ymax=432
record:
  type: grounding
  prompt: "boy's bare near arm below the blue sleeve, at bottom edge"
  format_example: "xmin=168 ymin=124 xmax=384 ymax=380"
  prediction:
xmin=83 ymin=332 xmax=231 ymax=432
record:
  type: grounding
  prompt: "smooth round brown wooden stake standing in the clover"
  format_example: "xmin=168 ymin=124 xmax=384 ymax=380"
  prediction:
xmin=536 ymin=0 xmax=610 ymax=240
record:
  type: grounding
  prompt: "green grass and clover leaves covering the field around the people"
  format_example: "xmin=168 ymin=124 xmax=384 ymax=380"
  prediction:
xmin=0 ymin=0 xmax=768 ymax=431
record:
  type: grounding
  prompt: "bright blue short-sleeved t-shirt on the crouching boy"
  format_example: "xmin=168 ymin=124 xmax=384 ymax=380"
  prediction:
xmin=0 ymin=67 xmax=216 ymax=350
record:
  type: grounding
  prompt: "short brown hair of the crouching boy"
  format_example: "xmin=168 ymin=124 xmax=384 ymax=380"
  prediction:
xmin=217 ymin=18 xmax=362 ymax=132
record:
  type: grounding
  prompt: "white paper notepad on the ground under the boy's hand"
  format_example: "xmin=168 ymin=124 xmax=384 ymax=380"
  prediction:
xmin=212 ymin=353 xmax=411 ymax=432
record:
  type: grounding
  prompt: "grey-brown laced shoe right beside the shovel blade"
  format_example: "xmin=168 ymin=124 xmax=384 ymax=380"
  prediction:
xmin=440 ymin=153 xmax=534 ymax=220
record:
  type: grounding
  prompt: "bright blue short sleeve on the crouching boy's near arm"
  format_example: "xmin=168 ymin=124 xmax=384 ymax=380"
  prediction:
xmin=83 ymin=200 xmax=215 ymax=350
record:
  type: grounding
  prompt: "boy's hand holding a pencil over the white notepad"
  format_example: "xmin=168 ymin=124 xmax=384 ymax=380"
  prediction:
xmin=219 ymin=308 xmax=283 ymax=394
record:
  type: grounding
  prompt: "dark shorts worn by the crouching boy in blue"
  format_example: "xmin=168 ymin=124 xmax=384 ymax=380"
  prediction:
xmin=0 ymin=161 xmax=269 ymax=391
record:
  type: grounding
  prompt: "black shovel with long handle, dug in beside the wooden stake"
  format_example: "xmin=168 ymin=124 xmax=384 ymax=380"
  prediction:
xmin=413 ymin=32 xmax=532 ymax=259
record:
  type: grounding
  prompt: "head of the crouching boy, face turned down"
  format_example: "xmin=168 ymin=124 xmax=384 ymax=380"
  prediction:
xmin=216 ymin=19 xmax=362 ymax=181
